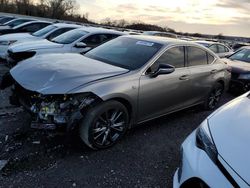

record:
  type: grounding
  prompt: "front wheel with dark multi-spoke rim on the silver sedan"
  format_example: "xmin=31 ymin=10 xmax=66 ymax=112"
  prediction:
xmin=79 ymin=101 xmax=129 ymax=149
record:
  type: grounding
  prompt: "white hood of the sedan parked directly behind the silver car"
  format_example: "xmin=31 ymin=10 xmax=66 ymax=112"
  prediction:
xmin=9 ymin=39 xmax=63 ymax=52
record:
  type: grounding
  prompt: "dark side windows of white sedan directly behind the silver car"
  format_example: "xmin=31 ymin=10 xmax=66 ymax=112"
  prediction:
xmin=82 ymin=34 xmax=114 ymax=47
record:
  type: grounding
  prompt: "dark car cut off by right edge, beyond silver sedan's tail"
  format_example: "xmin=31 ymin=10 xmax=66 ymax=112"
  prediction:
xmin=224 ymin=46 xmax=250 ymax=93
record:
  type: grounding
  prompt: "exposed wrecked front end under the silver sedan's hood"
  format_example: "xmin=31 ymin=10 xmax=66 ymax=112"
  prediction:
xmin=30 ymin=93 xmax=98 ymax=129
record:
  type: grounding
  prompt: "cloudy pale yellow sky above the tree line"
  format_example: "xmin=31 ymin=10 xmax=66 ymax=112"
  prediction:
xmin=77 ymin=0 xmax=250 ymax=37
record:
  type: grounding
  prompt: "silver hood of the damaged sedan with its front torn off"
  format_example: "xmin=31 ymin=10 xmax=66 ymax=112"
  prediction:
xmin=10 ymin=53 xmax=128 ymax=94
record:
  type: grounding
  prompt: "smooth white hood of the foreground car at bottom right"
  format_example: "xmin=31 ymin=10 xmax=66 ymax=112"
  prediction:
xmin=208 ymin=93 xmax=250 ymax=184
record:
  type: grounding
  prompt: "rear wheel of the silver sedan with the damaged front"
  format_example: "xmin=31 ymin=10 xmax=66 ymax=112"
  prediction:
xmin=204 ymin=82 xmax=224 ymax=110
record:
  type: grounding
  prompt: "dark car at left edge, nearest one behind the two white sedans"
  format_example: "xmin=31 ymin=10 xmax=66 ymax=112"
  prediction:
xmin=0 ymin=21 xmax=51 ymax=35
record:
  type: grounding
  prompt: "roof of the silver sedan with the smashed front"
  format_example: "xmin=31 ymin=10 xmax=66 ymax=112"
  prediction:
xmin=121 ymin=35 xmax=201 ymax=47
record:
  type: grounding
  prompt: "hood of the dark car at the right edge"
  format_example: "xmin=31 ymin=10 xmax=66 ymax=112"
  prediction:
xmin=223 ymin=59 xmax=250 ymax=73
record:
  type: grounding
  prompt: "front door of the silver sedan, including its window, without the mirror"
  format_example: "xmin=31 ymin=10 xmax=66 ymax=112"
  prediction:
xmin=138 ymin=46 xmax=192 ymax=122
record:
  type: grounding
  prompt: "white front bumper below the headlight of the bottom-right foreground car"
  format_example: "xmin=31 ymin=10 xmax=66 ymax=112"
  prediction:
xmin=173 ymin=131 xmax=232 ymax=188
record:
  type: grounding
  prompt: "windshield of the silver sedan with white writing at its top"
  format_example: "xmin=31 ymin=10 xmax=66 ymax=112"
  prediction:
xmin=85 ymin=37 xmax=162 ymax=70
